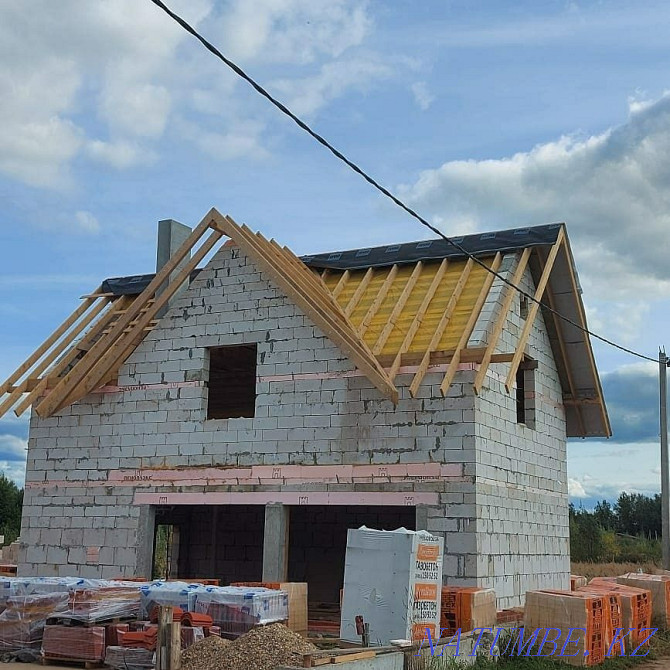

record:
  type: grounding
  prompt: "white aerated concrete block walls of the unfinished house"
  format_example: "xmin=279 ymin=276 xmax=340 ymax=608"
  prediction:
xmin=19 ymin=246 xmax=567 ymax=604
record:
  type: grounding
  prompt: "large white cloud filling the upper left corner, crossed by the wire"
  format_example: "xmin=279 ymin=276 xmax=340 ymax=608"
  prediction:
xmin=0 ymin=0 xmax=383 ymax=189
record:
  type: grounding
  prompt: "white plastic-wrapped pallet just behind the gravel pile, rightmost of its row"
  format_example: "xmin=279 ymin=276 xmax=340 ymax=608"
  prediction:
xmin=195 ymin=586 xmax=288 ymax=634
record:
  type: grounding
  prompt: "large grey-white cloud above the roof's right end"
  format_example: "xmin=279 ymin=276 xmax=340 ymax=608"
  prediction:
xmin=402 ymin=95 xmax=670 ymax=299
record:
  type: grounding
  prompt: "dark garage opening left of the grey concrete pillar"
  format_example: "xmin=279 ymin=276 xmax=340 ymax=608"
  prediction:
xmin=153 ymin=505 xmax=265 ymax=585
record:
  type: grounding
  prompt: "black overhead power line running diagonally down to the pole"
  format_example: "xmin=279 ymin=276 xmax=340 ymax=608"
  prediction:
xmin=146 ymin=0 xmax=658 ymax=363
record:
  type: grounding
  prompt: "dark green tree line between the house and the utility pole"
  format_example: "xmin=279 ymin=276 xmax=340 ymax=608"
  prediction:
xmin=570 ymin=493 xmax=661 ymax=562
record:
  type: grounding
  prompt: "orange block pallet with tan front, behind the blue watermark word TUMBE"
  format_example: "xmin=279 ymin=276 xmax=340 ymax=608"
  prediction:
xmin=524 ymin=591 xmax=607 ymax=666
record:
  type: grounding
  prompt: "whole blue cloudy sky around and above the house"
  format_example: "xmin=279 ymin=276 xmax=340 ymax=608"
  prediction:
xmin=0 ymin=0 xmax=670 ymax=501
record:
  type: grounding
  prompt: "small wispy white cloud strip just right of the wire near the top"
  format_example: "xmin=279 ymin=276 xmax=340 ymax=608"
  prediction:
xmin=273 ymin=58 xmax=393 ymax=116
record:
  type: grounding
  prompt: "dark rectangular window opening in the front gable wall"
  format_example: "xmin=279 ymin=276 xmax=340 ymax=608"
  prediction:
xmin=207 ymin=344 xmax=257 ymax=419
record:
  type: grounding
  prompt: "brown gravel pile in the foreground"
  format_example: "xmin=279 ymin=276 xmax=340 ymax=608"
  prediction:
xmin=181 ymin=623 xmax=317 ymax=670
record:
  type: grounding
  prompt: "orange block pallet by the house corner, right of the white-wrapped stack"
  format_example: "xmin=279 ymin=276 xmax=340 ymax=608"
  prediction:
xmin=440 ymin=586 xmax=497 ymax=635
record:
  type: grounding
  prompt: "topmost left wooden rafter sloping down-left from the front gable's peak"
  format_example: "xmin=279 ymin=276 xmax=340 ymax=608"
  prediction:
xmin=36 ymin=210 xmax=215 ymax=416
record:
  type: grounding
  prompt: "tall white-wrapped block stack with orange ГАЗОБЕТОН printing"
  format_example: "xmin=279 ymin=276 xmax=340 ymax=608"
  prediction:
xmin=340 ymin=527 xmax=444 ymax=645
